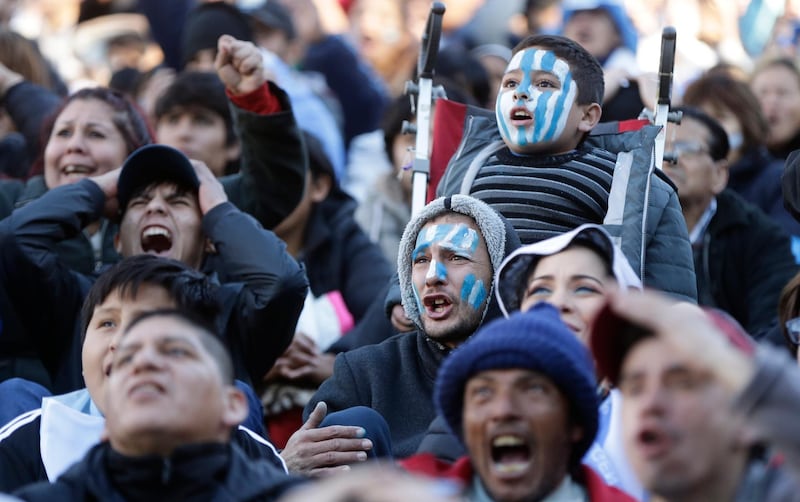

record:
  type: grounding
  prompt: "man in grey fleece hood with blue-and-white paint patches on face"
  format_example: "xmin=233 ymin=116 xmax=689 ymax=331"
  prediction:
xmin=281 ymin=195 xmax=519 ymax=474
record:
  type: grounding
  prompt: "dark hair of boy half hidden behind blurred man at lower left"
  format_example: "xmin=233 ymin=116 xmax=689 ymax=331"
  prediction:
xmin=81 ymin=254 xmax=220 ymax=338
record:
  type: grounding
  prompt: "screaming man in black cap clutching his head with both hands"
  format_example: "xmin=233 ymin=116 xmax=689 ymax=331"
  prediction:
xmin=0 ymin=139 xmax=307 ymax=392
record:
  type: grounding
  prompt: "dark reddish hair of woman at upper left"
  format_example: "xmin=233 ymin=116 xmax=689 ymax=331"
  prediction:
xmin=30 ymin=87 xmax=155 ymax=176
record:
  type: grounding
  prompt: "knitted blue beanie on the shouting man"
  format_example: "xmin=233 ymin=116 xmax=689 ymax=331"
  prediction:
xmin=434 ymin=302 xmax=599 ymax=459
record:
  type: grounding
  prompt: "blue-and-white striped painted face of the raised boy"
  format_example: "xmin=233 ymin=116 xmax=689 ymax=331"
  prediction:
xmin=495 ymin=48 xmax=578 ymax=150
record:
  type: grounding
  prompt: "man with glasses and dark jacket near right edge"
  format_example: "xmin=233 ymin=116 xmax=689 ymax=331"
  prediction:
xmin=664 ymin=107 xmax=797 ymax=339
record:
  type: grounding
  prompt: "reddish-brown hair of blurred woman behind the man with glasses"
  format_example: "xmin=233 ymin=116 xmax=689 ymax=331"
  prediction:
xmin=682 ymin=69 xmax=769 ymax=151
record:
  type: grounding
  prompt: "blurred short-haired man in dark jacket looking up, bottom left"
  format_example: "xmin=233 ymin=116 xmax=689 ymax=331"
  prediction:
xmin=16 ymin=310 xmax=306 ymax=501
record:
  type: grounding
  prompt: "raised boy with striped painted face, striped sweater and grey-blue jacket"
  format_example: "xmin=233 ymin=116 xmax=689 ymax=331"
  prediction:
xmin=437 ymin=35 xmax=697 ymax=301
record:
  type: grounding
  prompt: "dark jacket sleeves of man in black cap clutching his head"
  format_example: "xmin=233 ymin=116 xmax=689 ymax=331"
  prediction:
xmin=0 ymin=180 xmax=308 ymax=393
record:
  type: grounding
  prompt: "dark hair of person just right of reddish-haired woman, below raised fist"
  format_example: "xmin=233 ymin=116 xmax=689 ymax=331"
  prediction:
xmin=154 ymin=71 xmax=234 ymax=146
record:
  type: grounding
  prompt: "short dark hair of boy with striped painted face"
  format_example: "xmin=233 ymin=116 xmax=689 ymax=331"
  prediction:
xmin=512 ymin=35 xmax=605 ymax=105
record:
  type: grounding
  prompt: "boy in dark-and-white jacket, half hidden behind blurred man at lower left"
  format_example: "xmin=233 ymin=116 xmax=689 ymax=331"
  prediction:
xmin=0 ymin=254 xmax=286 ymax=492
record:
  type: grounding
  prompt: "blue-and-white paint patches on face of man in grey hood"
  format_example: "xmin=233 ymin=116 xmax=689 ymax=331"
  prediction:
xmin=412 ymin=223 xmax=487 ymax=312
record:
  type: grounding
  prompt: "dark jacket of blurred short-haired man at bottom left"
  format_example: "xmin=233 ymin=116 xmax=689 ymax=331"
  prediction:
xmin=14 ymin=442 xmax=303 ymax=502
